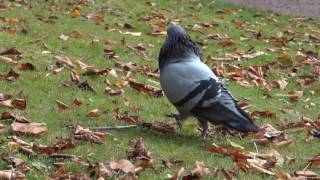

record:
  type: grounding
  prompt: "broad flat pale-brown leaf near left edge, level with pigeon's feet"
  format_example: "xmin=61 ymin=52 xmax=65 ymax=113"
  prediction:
xmin=11 ymin=122 xmax=48 ymax=135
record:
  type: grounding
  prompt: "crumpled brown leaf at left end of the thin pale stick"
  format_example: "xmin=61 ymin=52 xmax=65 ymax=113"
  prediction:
xmin=73 ymin=125 xmax=107 ymax=144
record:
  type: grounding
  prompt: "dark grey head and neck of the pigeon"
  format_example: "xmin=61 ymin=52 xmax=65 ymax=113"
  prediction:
xmin=159 ymin=25 xmax=202 ymax=71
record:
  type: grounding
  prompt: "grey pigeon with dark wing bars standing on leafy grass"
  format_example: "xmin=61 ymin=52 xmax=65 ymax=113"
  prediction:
xmin=159 ymin=25 xmax=259 ymax=136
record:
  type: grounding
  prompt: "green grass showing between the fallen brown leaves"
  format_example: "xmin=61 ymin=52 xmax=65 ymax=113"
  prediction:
xmin=0 ymin=0 xmax=320 ymax=179
